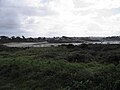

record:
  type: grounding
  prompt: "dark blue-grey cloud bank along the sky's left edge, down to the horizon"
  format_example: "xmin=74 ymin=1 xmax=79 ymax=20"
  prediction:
xmin=0 ymin=0 xmax=24 ymax=35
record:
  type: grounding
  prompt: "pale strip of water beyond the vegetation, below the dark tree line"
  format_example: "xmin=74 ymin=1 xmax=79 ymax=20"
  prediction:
xmin=3 ymin=41 xmax=120 ymax=47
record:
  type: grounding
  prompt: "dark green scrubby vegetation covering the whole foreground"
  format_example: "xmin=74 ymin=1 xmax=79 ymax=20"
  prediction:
xmin=0 ymin=44 xmax=120 ymax=90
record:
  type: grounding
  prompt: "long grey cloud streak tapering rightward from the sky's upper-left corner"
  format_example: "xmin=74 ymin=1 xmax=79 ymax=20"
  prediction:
xmin=0 ymin=0 xmax=55 ymax=16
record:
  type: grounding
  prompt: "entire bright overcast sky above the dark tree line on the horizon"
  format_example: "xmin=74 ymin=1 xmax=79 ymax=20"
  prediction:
xmin=0 ymin=0 xmax=120 ymax=37
